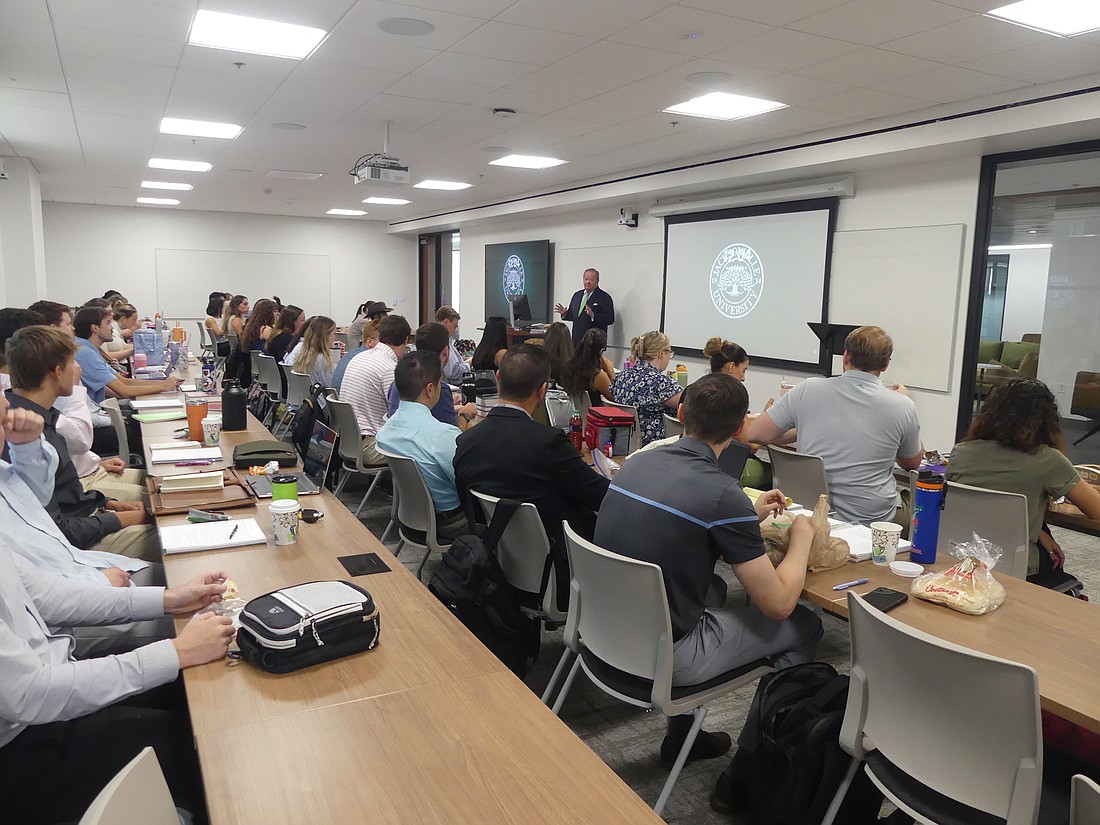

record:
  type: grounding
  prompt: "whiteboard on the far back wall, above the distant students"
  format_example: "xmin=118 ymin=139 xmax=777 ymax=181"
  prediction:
xmin=156 ymin=249 xmax=332 ymax=318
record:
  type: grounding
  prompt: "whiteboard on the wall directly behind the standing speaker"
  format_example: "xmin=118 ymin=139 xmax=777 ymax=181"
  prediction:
xmin=553 ymin=243 xmax=664 ymax=349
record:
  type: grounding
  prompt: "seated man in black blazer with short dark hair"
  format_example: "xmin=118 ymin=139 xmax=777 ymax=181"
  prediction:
xmin=454 ymin=344 xmax=608 ymax=605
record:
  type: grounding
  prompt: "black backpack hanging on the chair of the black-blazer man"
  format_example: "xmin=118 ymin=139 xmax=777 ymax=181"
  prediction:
xmin=428 ymin=498 xmax=541 ymax=679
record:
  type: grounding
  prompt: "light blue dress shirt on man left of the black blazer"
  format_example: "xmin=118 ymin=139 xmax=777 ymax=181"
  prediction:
xmin=377 ymin=402 xmax=461 ymax=513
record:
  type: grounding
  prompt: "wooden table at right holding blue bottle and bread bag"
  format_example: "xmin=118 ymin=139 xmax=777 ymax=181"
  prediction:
xmin=803 ymin=553 xmax=1100 ymax=733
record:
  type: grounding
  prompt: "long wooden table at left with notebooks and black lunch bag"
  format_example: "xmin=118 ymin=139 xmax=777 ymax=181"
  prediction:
xmin=142 ymin=393 xmax=661 ymax=825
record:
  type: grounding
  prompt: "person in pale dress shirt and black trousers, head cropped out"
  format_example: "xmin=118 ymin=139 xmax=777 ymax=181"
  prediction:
xmin=0 ymin=550 xmax=233 ymax=825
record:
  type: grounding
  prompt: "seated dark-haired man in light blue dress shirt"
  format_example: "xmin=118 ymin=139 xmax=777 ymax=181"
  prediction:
xmin=377 ymin=350 xmax=466 ymax=539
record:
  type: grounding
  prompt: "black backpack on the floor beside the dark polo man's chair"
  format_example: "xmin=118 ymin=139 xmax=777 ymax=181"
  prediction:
xmin=716 ymin=662 xmax=882 ymax=825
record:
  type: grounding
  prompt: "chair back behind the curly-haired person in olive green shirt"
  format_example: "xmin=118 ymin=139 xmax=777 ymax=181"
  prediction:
xmin=937 ymin=482 xmax=1031 ymax=579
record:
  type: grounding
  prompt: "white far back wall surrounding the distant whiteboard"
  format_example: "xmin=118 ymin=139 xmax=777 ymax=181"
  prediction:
xmin=39 ymin=202 xmax=417 ymax=327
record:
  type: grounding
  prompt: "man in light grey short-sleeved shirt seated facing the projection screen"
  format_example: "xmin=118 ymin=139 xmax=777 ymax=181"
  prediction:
xmin=746 ymin=327 xmax=924 ymax=524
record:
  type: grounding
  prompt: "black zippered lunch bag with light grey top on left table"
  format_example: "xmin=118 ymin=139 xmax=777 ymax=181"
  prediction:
xmin=237 ymin=581 xmax=381 ymax=673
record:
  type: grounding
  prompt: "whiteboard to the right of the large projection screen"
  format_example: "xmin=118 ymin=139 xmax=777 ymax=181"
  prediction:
xmin=828 ymin=223 xmax=966 ymax=393
